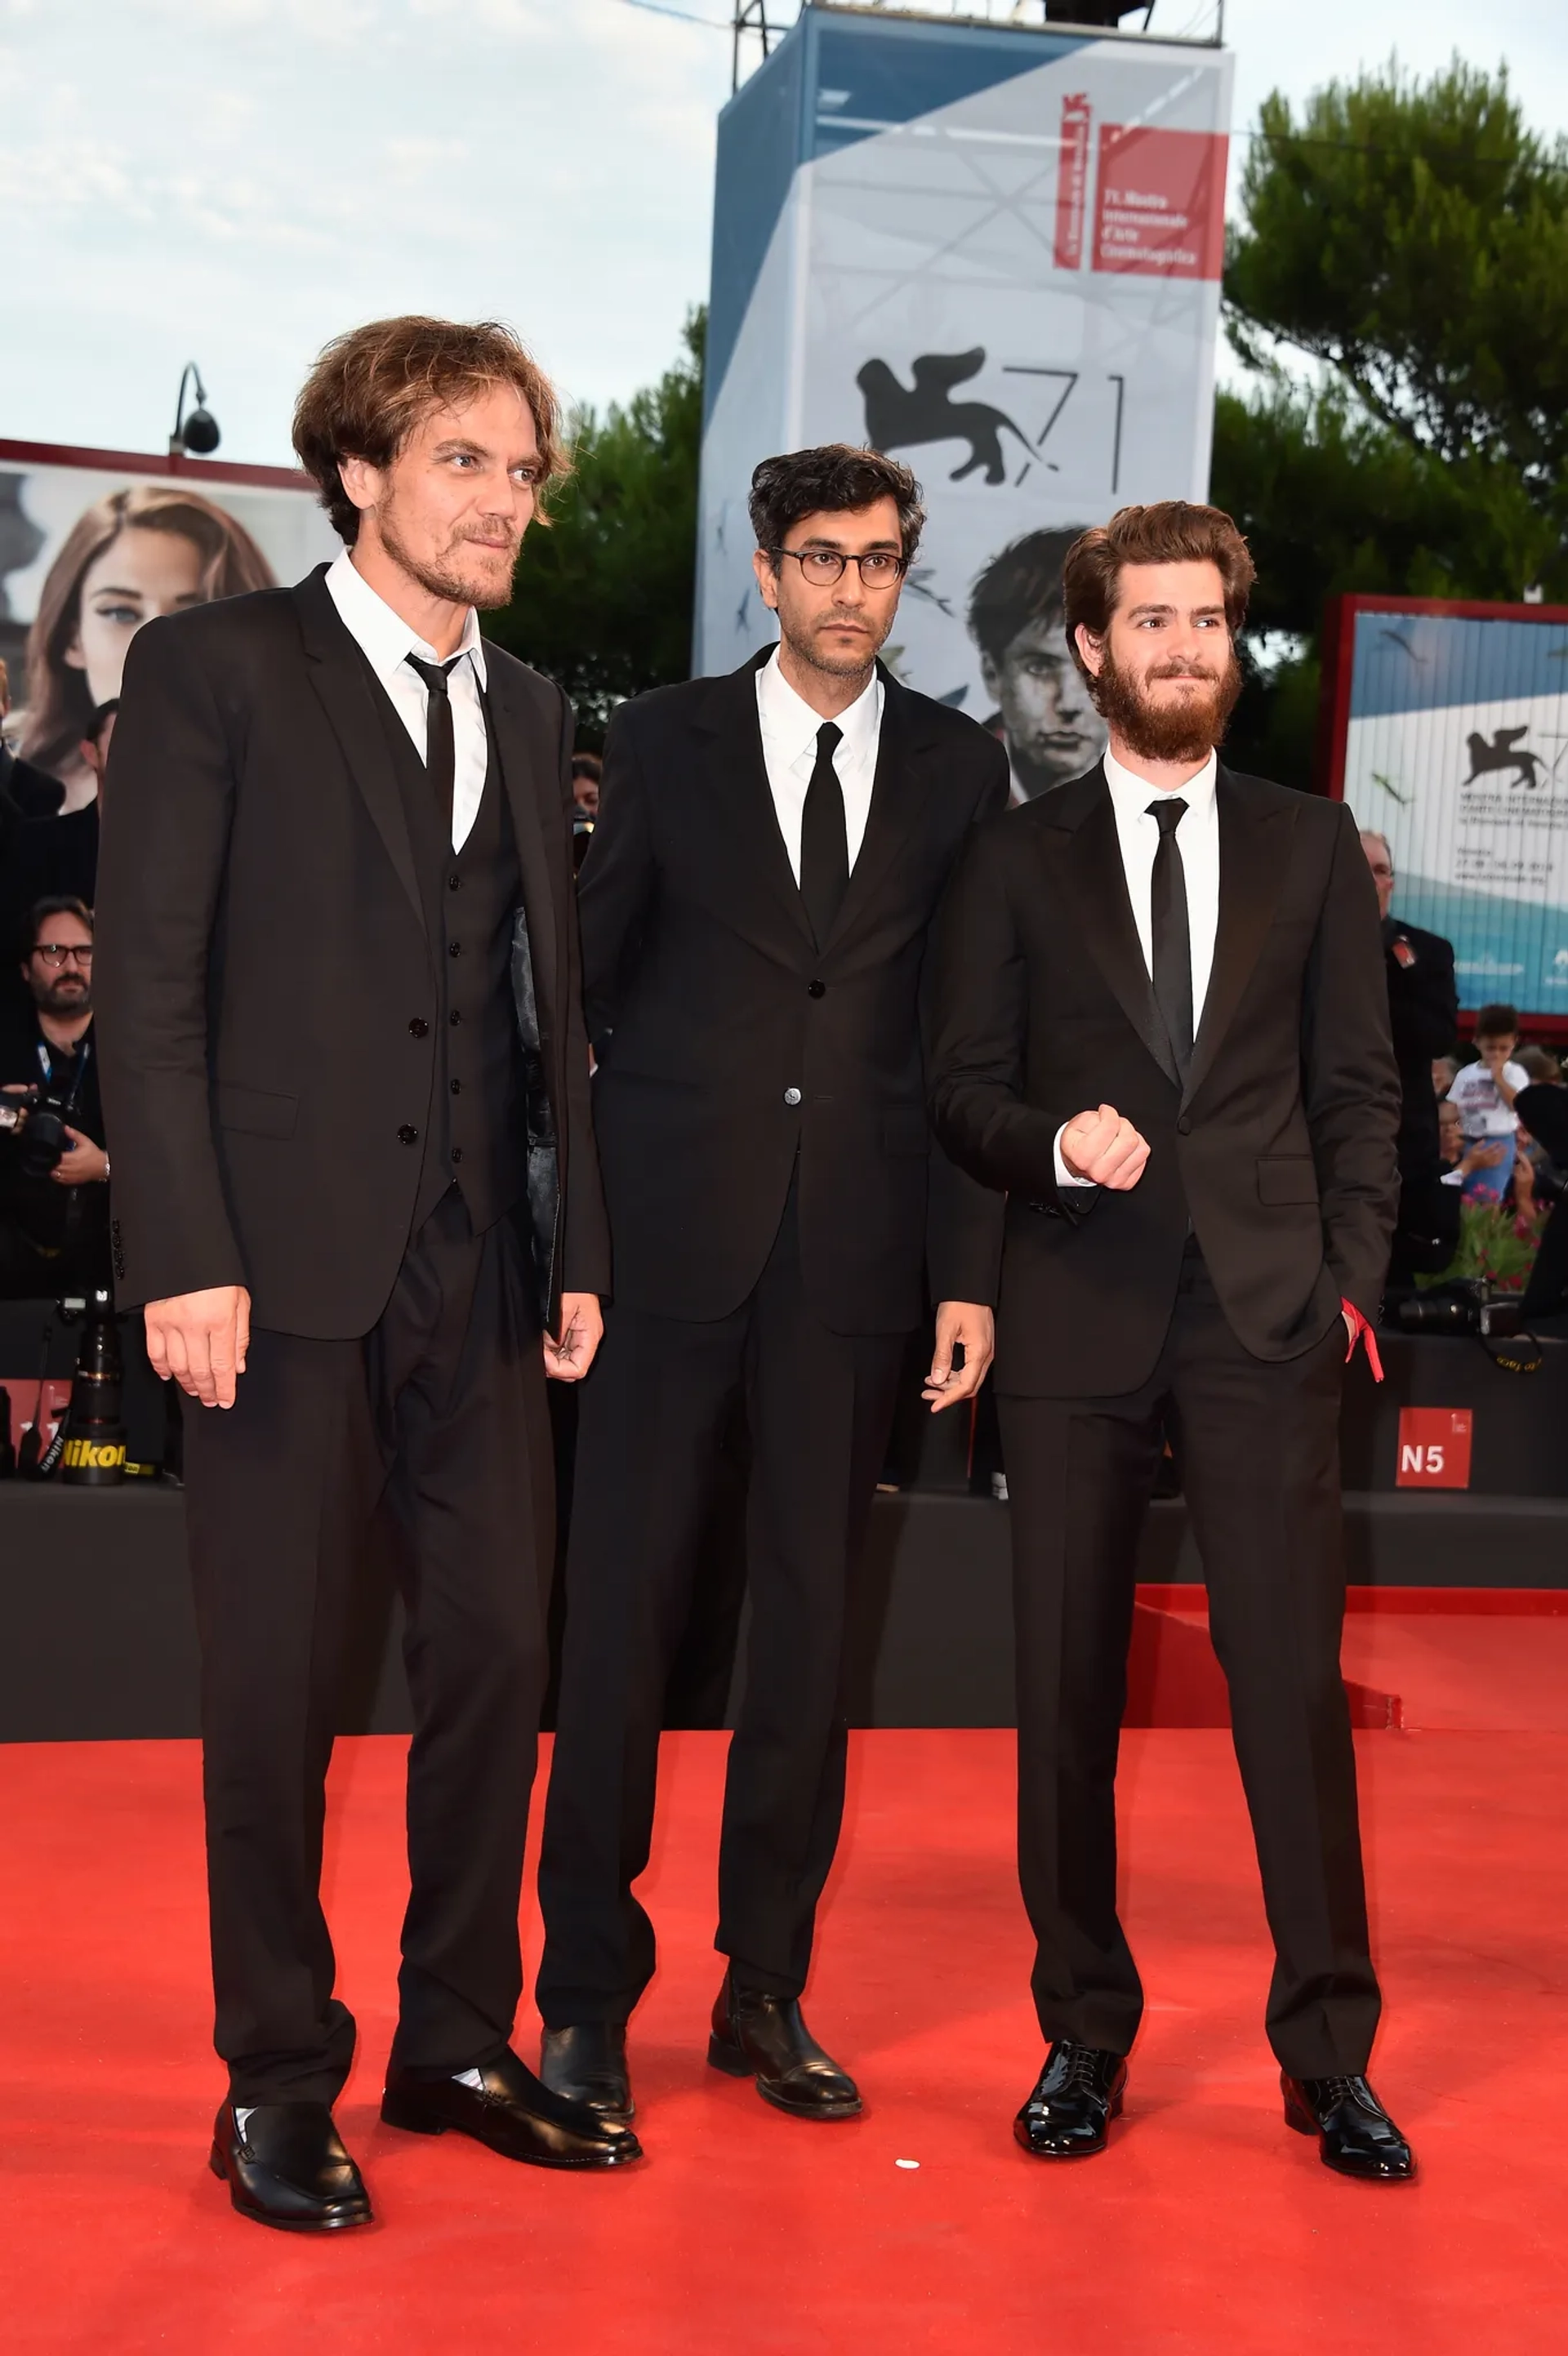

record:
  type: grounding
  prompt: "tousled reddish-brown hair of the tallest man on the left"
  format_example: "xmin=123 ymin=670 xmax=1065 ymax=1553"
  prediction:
xmin=294 ymin=316 xmax=570 ymax=546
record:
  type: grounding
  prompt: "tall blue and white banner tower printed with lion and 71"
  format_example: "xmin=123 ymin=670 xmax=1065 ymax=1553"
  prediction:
xmin=697 ymin=7 xmax=1232 ymax=789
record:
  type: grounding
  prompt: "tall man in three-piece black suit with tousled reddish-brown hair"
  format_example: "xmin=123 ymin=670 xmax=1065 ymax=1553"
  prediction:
xmin=99 ymin=318 xmax=638 ymax=2231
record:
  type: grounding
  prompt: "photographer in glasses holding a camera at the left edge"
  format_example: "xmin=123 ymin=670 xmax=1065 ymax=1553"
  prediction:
xmin=0 ymin=897 xmax=109 ymax=1301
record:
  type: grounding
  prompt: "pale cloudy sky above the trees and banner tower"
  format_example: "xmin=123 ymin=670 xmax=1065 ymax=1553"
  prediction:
xmin=0 ymin=0 xmax=1568 ymax=464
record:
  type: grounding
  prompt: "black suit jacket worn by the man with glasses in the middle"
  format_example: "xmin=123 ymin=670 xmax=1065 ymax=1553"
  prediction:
xmin=581 ymin=650 xmax=1008 ymax=1334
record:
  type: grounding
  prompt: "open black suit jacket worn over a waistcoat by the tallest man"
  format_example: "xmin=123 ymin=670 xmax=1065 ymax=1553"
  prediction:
xmin=94 ymin=568 xmax=610 ymax=1338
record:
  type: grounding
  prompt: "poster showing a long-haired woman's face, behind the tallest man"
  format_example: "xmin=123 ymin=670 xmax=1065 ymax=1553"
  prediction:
xmin=0 ymin=445 xmax=339 ymax=808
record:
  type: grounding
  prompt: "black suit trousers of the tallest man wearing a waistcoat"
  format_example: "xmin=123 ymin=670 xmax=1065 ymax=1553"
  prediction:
xmin=186 ymin=1190 xmax=551 ymax=2101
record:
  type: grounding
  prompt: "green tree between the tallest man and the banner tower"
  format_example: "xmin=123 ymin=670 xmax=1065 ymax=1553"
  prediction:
xmin=485 ymin=311 xmax=706 ymax=745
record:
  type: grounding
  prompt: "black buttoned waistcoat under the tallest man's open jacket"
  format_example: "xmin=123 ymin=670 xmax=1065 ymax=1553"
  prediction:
xmin=376 ymin=684 xmax=532 ymax=1235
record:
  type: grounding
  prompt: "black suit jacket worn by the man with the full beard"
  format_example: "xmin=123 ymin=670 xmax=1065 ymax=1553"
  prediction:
xmin=933 ymin=768 xmax=1398 ymax=1397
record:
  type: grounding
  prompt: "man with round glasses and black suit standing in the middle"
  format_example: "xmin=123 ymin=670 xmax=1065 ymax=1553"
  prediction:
xmin=539 ymin=445 xmax=1008 ymax=2118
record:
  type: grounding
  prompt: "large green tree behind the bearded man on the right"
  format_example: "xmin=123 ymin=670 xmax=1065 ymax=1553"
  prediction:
xmin=1213 ymin=61 xmax=1568 ymax=785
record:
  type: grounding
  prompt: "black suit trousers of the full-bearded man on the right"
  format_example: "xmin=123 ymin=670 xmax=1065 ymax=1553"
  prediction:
xmin=1000 ymin=1246 xmax=1379 ymax=2078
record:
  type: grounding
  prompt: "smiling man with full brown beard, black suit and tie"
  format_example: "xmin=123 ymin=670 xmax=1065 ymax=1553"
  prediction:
xmin=933 ymin=502 xmax=1413 ymax=2180
